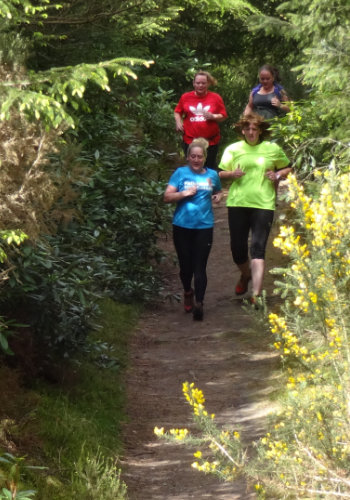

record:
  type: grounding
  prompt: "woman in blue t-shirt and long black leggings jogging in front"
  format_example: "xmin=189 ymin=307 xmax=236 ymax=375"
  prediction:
xmin=164 ymin=138 xmax=222 ymax=321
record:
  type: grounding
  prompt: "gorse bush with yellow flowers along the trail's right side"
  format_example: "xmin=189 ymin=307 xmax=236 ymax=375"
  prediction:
xmin=156 ymin=169 xmax=350 ymax=499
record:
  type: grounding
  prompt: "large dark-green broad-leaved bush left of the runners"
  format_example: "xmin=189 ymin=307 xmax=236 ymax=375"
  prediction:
xmin=0 ymin=89 xmax=171 ymax=355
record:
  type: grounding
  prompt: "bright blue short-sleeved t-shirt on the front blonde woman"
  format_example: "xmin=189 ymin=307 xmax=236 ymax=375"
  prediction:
xmin=169 ymin=165 xmax=221 ymax=229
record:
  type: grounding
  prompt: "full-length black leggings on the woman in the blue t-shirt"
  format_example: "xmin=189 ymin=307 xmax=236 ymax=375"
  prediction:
xmin=173 ymin=225 xmax=213 ymax=302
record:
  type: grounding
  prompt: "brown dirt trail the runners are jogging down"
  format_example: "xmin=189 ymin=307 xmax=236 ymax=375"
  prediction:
xmin=123 ymin=195 xmax=284 ymax=500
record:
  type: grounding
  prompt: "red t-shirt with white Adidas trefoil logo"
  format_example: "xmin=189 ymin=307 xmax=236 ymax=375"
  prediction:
xmin=175 ymin=90 xmax=227 ymax=146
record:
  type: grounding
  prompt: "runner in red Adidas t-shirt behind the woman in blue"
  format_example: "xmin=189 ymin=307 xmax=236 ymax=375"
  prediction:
xmin=174 ymin=71 xmax=227 ymax=168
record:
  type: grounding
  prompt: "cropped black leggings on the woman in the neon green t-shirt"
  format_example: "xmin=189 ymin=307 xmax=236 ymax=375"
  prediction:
xmin=228 ymin=207 xmax=274 ymax=265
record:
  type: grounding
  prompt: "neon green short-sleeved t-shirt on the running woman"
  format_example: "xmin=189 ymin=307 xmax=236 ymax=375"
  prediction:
xmin=219 ymin=141 xmax=289 ymax=210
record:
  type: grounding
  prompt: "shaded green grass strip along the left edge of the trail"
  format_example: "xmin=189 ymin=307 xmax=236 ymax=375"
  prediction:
xmin=1 ymin=300 xmax=140 ymax=500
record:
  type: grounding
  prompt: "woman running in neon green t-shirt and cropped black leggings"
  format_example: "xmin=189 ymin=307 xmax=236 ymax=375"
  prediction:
xmin=219 ymin=113 xmax=291 ymax=302
